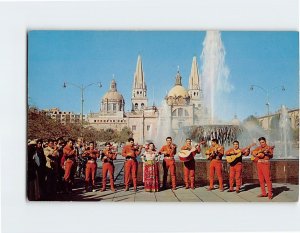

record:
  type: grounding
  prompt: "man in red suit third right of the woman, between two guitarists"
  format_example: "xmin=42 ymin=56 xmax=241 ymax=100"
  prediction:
xmin=205 ymin=139 xmax=224 ymax=192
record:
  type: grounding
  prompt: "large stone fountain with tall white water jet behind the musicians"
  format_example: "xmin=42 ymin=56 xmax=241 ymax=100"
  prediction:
xmin=136 ymin=31 xmax=299 ymax=185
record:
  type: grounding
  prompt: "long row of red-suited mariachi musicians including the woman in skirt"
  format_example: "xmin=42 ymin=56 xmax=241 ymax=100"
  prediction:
xmin=27 ymin=137 xmax=274 ymax=199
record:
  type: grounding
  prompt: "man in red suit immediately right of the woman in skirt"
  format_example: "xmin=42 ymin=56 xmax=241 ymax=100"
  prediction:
xmin=159 ymin=137 xmax=177 ymax=190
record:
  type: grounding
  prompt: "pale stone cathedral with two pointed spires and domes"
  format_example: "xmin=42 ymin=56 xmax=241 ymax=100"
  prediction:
xmin=87 ymin=55 xmax=208 ymax=143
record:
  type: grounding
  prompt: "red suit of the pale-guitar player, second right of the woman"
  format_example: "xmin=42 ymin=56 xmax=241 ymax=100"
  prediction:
xmin=181 ymin=145 xmax=201 ymax=189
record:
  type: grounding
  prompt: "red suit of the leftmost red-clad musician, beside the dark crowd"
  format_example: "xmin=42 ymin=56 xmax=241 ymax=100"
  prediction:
xmin=61 ymin=145 xmax=76 ymax=183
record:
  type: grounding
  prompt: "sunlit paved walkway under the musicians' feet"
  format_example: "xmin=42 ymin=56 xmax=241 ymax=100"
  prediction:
xmin=56 ymin=183 xmax=299 ymax=202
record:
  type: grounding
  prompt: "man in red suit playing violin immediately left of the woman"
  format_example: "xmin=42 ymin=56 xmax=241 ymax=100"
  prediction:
xmin=122 ymin=138 xmax=142 ymax=192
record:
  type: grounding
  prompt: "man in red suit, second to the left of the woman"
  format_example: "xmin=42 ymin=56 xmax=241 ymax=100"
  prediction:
xmin=101 ymin=142 xmax=117 ymax=192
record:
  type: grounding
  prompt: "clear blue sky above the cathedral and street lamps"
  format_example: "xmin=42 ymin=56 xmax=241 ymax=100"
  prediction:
xmin=28 ymin=30 xmax=299 ymax=120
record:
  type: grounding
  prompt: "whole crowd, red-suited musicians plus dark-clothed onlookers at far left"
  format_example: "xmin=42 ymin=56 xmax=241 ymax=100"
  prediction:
xmin=27 ymin=137 xmax=274 ymax=200
